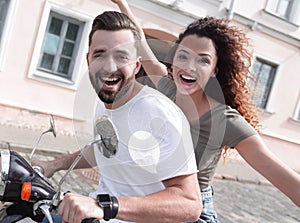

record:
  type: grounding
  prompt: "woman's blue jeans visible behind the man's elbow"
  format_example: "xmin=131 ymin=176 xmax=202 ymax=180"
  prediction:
xmin=189 ymin=186 xmax=219 ymax=223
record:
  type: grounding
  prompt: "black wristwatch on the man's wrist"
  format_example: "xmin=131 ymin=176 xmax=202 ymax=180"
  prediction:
xmin=97 ymin=194 xmax=119 ymax=221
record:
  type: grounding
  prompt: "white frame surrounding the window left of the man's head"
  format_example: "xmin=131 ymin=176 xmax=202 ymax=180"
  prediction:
xmin=27 ymin=1 xmax=92 ymax=89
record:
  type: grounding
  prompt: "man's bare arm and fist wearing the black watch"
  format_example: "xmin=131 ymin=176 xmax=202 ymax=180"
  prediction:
xmin=58 ymin=174 xmax=202 ymax=223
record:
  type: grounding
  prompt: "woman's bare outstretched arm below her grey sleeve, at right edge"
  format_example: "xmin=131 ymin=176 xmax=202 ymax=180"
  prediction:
xmin=236 ymin=135 xmax=300 ymax=207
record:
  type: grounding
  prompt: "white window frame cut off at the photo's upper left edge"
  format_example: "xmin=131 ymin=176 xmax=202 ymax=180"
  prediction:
xmin=0 ymin=0 xmax=17 ymax=71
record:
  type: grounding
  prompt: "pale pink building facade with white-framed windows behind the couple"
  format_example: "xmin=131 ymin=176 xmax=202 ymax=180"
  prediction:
xmin=0 ymin=0 xmax=300 ymax=171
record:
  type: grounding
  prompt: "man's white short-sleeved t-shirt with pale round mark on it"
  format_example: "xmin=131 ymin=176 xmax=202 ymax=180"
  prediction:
xmin=90 ymin=86 xmax=197 ymax=222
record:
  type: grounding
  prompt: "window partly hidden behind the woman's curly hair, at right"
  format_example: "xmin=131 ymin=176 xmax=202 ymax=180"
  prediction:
xmin=249 ymin=58 xmax=278 ymax=109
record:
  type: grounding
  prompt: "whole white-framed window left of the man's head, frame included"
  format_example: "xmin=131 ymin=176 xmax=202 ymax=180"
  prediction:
xmin=28 ymin=1 xmax=92 ymax=89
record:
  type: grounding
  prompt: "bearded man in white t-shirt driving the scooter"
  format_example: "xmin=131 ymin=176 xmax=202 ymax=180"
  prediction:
xmin=33 ymin=12 xmax=202 ymax=223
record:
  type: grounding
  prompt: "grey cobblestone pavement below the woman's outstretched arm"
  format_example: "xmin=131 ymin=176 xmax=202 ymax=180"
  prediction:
xmin=214 ymin=180 xmax=300 ymax=223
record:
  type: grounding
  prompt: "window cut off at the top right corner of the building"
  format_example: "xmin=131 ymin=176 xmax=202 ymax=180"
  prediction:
xmin=267 ymin=0 xmax=296 ymax=21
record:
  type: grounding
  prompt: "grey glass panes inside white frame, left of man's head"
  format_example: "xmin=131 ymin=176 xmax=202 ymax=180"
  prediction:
xmin=38 ymin=12 xmax=84 ymax=80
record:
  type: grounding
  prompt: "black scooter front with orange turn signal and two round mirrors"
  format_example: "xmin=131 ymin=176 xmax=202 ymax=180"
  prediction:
xmin=0 ymin=115 xmax=118 ymax=223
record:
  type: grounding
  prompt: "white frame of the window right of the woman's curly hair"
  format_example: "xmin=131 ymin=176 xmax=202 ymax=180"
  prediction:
xmin=250 ymin=54 xmax=281 ymax=114
